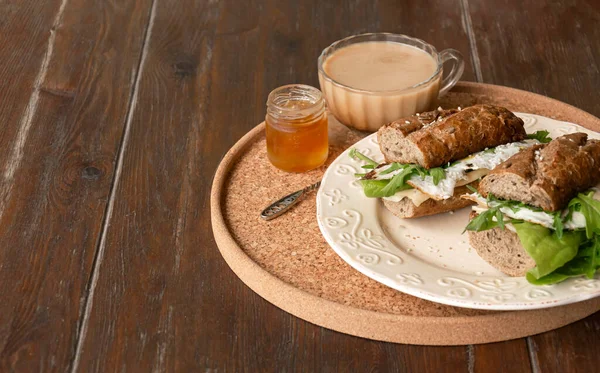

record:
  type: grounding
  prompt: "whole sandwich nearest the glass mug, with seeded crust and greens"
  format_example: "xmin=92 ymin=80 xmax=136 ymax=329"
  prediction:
xmin=350 ymin=105 xmax=549 ymax=218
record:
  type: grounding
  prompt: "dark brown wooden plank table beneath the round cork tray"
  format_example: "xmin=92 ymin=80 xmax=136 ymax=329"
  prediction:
xmin=0 ymin=0 xmax=600 ymax=372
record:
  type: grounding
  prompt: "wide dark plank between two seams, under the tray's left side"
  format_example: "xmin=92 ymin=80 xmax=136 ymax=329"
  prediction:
xmin=76 ymin=0 xmax=473 ymax=372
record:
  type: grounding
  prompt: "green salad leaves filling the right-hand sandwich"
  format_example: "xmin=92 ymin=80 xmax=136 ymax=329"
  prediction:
xmin=465 ymin=191 xmax=600 ymax=285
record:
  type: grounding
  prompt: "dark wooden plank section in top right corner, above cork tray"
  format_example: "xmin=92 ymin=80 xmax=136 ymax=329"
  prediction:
xmin=468 ymin=0 xmax=600 ymax=116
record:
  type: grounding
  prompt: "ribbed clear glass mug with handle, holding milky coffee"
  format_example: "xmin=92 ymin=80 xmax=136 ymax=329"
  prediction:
xmin=318 ymin=33 xmax=464 ymax=131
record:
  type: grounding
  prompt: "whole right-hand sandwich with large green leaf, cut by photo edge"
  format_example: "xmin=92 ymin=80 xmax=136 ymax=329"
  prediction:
xmin=464 ymin=133 xmax=600 ymax=285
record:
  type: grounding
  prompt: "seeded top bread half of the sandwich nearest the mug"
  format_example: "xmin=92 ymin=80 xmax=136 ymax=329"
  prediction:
xmin=377 ymin=105 xmax=526 ymax=169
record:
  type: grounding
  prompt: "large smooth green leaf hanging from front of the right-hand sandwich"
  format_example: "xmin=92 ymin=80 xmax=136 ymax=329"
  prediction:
xmin=514 ymin=222 xmax=585 ymax=279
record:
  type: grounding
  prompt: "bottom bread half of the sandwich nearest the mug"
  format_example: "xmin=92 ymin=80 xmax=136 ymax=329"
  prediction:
xmin=383 ymin=182 xmax=477 ymax=219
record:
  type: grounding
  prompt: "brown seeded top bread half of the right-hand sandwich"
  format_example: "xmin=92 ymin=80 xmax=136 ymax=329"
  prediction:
xmin=479 ymin=132 xmax=600 ymax=211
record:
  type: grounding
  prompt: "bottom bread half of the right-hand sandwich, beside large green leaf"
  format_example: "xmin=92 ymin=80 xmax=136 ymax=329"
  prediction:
xmin=469 ymin=211 xmax=535 ymax=277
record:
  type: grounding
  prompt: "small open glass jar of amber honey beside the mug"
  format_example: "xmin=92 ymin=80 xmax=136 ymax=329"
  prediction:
xmin=266 ymin=84 xmax=329 ymax=172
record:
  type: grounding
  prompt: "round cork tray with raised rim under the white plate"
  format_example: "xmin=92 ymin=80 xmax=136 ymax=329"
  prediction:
xmin=211 ymin=82 xmax=600 ymax=345
